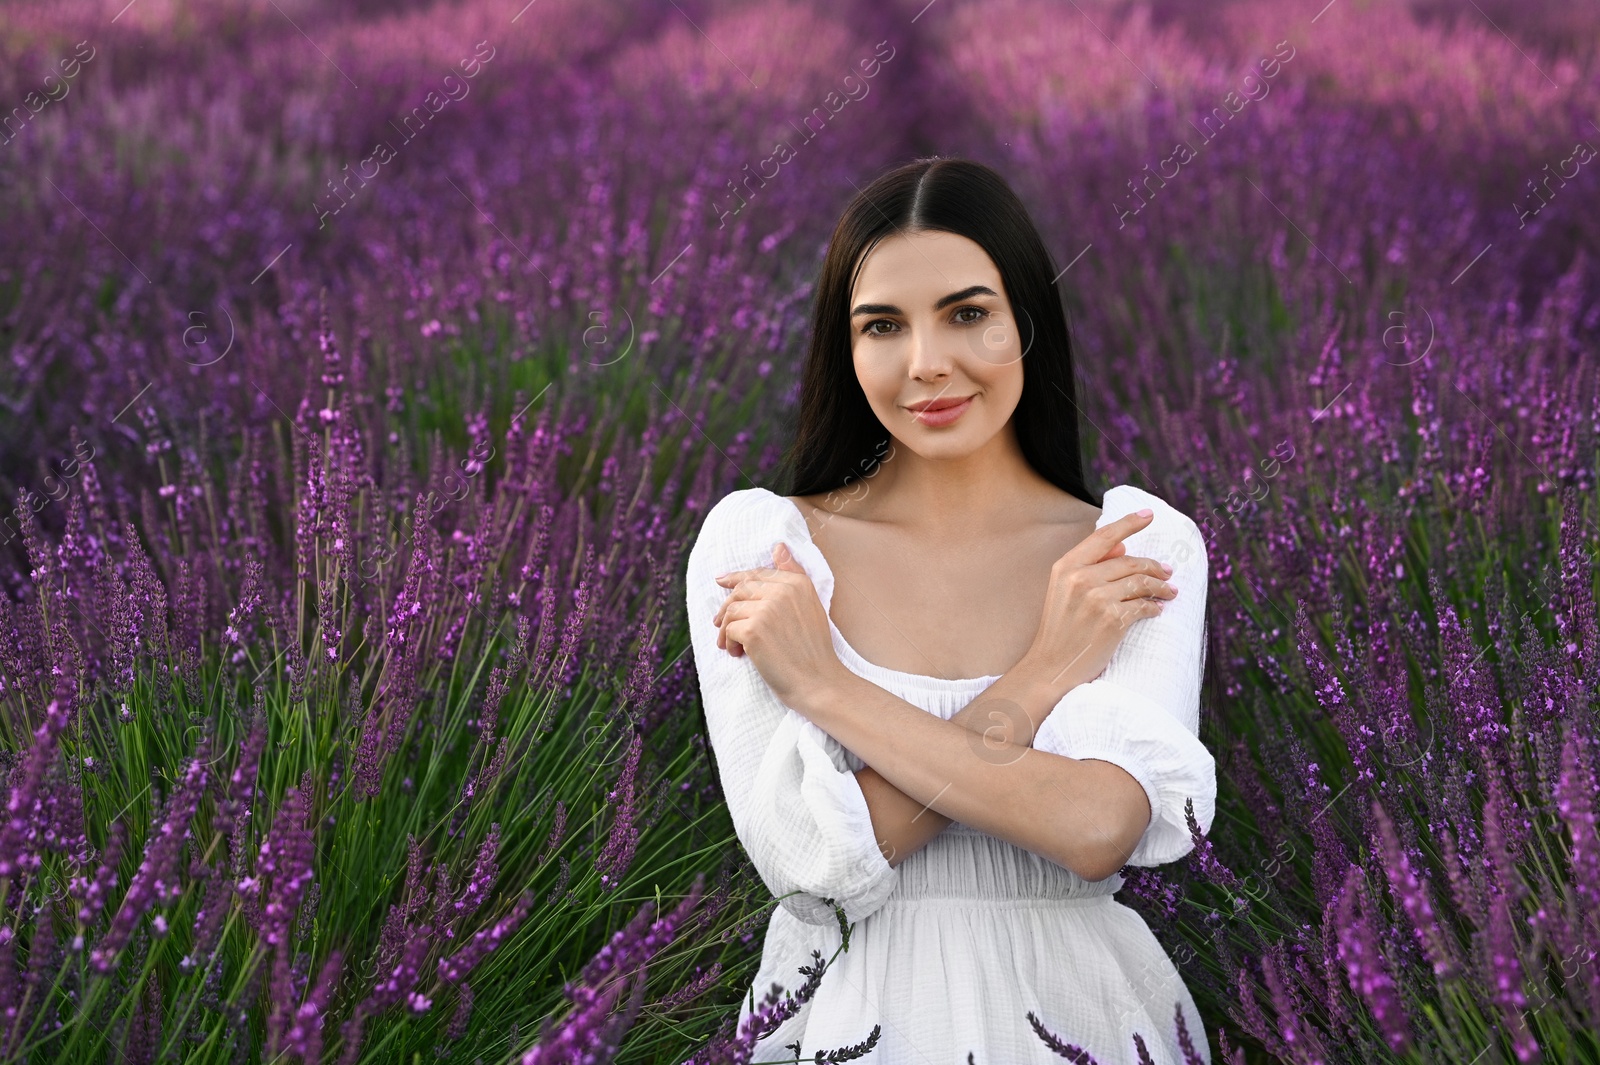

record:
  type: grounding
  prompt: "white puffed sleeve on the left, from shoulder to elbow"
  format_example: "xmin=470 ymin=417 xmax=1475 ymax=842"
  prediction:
xmin=685 ymin=488 xmax=899 ymax=924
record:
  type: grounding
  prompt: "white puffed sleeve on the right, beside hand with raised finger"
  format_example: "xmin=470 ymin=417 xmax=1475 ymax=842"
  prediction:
xmin=1034 ymin=485 xmax=1216 ymax=865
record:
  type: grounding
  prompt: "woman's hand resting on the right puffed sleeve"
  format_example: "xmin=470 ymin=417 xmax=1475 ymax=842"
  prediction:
xmin=1026 ymin=512 xmax=1178 ymax=700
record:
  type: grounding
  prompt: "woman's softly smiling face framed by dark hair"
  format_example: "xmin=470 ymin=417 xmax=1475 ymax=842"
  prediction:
xmin=850 ymin=232 xmax=1022 ymax=459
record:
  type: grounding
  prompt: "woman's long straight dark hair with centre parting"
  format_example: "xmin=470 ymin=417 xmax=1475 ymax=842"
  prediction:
xmin=778 ymin=157 xmax=1102 ymax=507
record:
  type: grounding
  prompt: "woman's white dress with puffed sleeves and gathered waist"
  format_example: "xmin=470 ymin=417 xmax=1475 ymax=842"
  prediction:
xmin=686 ymin=485 xmax=1216 ymax=1065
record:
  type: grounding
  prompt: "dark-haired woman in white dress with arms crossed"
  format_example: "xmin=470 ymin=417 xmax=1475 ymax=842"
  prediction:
xmin=686 ymin=158 xmax=1216 ymax=1065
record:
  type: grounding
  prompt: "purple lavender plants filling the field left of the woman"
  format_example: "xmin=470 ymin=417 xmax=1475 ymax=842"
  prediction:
xmin=0 ymin=5 xmax=934 ymax=1060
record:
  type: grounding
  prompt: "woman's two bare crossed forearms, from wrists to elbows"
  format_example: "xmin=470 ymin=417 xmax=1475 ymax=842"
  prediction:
xmin=795 ymin=657 xmax=1152 ymax=881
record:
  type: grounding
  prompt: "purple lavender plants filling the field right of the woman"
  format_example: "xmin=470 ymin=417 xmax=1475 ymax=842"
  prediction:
xmin=876 ymin=5 xmax=1600 ymax=1062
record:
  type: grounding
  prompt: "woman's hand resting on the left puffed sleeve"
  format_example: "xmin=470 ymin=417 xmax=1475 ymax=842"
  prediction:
xmin=712 ymin=542 xmax=843 ymax=707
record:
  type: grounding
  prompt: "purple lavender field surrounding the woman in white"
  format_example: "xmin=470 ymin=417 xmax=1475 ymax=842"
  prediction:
xmin=0 ymin=0 xmax=1600 ymax=1065
